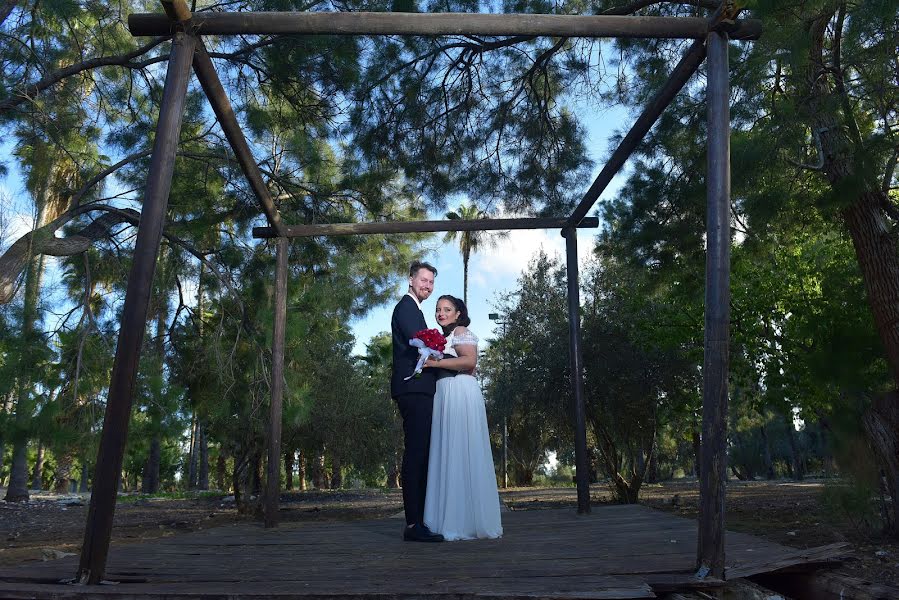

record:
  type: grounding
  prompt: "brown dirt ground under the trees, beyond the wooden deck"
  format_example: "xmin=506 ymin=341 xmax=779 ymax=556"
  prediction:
xmin=0 ymin=481 xmax=899 ymax=586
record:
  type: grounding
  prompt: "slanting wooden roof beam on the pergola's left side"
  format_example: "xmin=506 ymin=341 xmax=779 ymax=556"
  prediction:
xmin=194 ymin=40 xmax=284 ymax=235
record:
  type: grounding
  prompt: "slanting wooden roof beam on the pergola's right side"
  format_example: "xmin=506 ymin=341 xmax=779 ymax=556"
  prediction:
xmin=568 ymin=40 xmax=705 ymax=226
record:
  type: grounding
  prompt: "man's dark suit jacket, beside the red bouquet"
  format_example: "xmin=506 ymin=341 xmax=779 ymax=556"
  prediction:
xmin=390 ymin=294 xmax=437 ymax=398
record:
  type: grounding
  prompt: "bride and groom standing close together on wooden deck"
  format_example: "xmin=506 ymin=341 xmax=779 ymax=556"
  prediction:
xmin=390 ymin=262 xmax=503 ymax=542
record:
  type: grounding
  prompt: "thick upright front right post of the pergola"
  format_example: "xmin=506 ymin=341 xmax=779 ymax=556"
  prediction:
xmin=697 ymin=32 xmax=730 ymax=579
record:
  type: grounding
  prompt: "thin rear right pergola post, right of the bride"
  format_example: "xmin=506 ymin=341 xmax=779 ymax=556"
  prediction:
xmin=562 ymin=228 xmax=590 ymax=514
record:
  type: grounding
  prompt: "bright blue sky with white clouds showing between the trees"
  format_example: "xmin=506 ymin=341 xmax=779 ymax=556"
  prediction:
xmin=0 ymin=82 xmax=634 ymax=354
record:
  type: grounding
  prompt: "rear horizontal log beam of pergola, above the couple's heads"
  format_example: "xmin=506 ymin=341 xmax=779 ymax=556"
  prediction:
xmin=253 ymin=217 xmax=599 ymax=238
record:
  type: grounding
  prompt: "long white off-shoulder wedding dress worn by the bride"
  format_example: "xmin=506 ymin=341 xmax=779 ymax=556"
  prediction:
xmin=424 ymin=331 xmax=503 ymax=541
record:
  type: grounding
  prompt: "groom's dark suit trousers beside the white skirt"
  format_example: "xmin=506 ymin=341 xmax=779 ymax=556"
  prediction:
xmin=396 ymin=394 xmax=434 ymax=525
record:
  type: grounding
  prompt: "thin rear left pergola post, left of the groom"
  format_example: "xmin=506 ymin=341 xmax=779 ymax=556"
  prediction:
xmin=265 ymin=238 xmax=288 ymax=527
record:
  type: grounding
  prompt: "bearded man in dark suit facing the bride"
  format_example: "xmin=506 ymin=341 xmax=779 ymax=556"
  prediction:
xmin=390 ymin=261 xmax=443 ymax=542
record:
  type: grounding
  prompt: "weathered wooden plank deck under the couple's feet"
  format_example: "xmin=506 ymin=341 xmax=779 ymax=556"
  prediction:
xmin=0 ymin=505 xmax=844 ymax=600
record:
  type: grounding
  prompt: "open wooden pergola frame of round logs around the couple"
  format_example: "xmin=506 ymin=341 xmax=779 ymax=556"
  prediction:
xmin=76 ymin=0 xmax=762 ymax=584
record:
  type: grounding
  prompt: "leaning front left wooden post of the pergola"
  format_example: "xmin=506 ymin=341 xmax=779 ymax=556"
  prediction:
xmin=76 ymin=33 xmax=196 ymax=584
